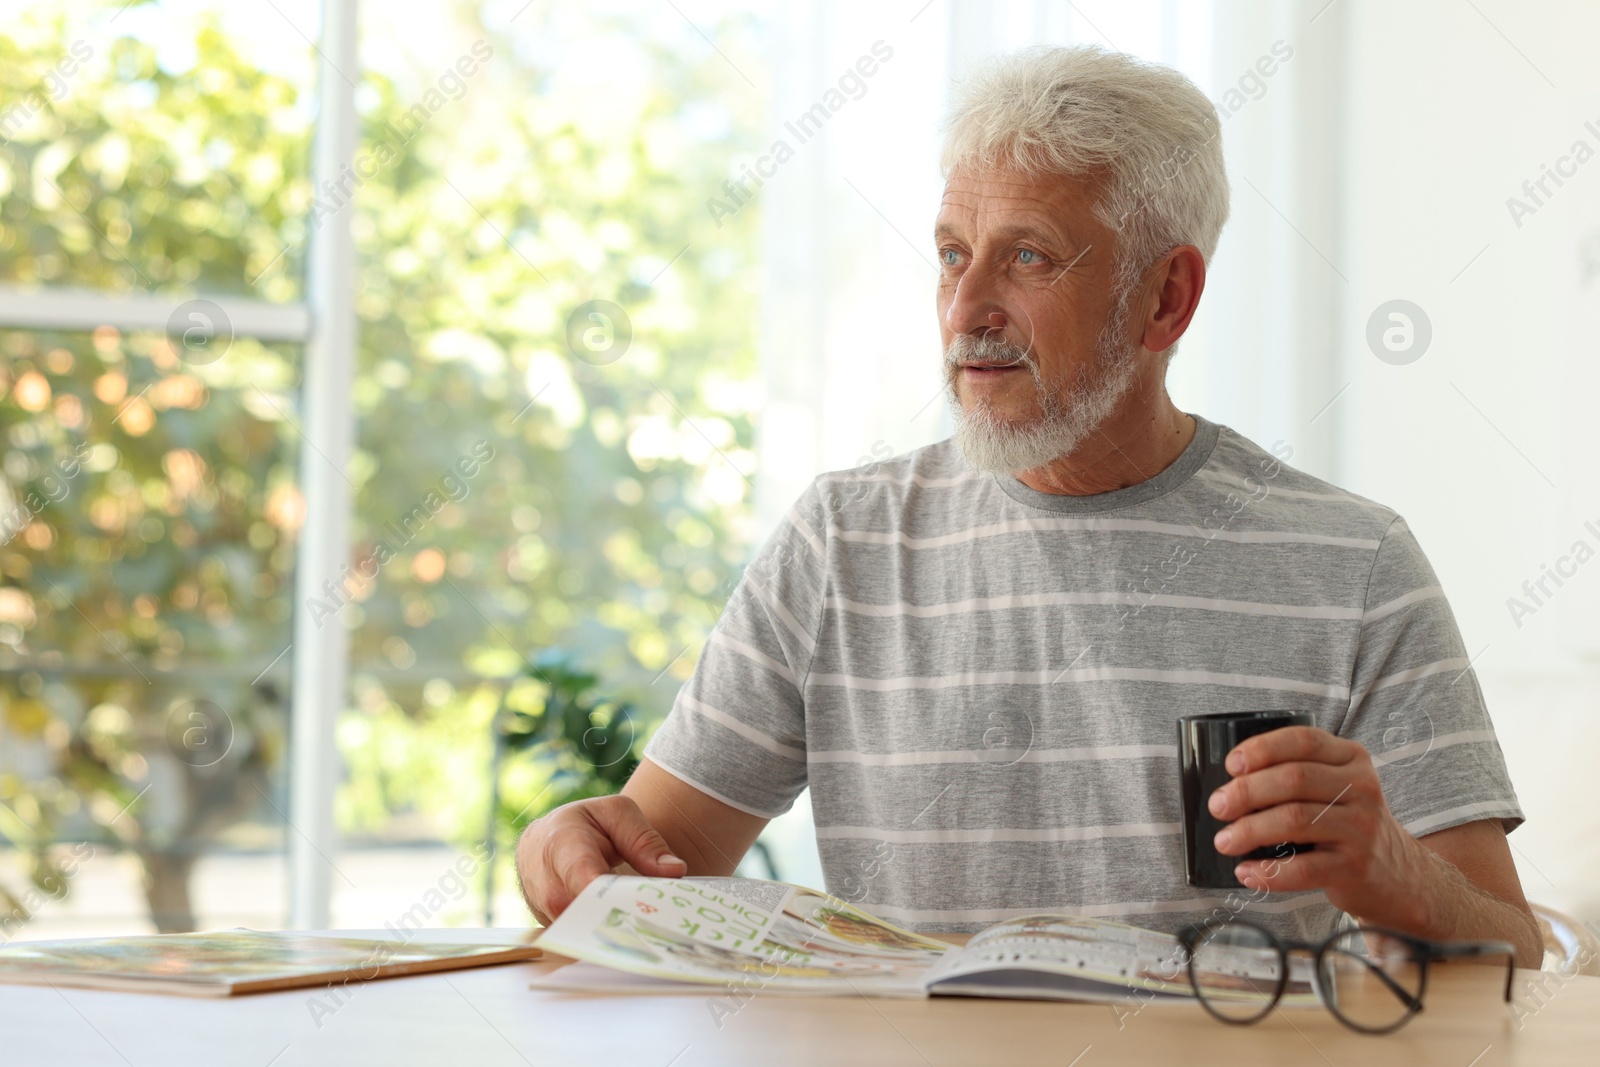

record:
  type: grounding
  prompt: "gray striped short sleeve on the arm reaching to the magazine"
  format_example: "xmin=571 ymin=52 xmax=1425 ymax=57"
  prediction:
xmin=645 ymin=483 xmax=827 ymax=819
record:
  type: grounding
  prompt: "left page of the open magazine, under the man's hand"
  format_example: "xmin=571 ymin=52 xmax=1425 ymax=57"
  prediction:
xmin=538 ymin=875 xmax=950 ymax=997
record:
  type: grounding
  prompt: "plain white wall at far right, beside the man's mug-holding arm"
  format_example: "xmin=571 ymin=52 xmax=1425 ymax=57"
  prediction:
xmin=1336 ymin=0 xmax=1600 ymax=918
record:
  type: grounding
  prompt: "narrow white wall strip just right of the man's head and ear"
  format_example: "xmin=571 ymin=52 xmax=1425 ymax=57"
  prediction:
xmin=1168 ymin=0 xmax=1349 ymax=480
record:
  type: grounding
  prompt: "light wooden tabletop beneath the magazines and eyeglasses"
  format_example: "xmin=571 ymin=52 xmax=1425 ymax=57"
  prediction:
xmin=9 ymin=929 xmax=1600 ymax=1067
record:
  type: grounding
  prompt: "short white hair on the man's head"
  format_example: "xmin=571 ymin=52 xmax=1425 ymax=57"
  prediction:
xmin=939 ymin=45 xmax=1227 ymax=319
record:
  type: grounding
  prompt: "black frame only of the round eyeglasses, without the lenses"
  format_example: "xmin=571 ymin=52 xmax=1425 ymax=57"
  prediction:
xmin=1178 ymin=918 xmax=1517 ymax=1033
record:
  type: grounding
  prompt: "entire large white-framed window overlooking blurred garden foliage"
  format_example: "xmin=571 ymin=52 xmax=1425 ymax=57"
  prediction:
xmin=0 ymin=3 xmax=760 ymax=936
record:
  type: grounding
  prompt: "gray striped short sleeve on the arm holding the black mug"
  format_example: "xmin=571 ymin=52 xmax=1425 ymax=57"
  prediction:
xmin=1339 ymin=518 xmax=1523 ymax=837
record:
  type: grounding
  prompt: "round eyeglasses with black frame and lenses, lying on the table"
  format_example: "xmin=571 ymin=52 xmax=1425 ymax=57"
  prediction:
xmin=1178 ymin=918 xmax=1517 ymax=1033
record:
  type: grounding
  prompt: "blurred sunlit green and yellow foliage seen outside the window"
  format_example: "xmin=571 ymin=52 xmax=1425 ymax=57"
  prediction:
xmin=0 ymin=2 xmax=760 ymax=928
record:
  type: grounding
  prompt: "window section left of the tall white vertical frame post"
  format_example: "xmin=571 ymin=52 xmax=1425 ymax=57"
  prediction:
xmin=0 ymin=5 xmax=312 ymax=937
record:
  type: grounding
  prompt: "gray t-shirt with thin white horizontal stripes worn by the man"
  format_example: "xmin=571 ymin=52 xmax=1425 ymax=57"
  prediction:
xmin=646 ymin=416 xmax=1522 ymax=937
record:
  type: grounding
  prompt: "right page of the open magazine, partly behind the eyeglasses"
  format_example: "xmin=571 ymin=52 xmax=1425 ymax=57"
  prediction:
xmin=928 ymin=915 xmax=1317 ymax=1006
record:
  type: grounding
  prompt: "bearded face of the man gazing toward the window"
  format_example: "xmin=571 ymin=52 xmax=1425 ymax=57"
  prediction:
xmin=934 ymin=170 xmax=1138 ymax=470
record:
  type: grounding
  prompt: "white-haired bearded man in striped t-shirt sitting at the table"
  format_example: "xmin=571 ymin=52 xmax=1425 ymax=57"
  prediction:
xmin=518 ymin=48 xmax=1541 ymax=966
